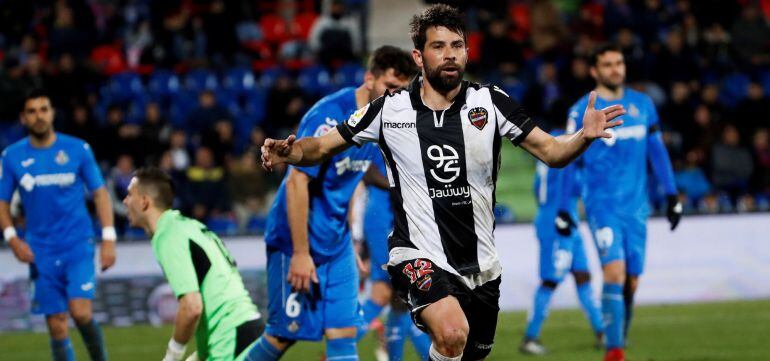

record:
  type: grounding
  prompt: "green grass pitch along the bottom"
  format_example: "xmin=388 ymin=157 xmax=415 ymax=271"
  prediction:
xmin=0 ymin=300 xmax=770 ymax=361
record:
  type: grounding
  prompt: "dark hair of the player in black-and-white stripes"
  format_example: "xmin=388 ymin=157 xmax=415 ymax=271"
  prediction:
xmin=409 ymin=4 xmax=465 ymax=50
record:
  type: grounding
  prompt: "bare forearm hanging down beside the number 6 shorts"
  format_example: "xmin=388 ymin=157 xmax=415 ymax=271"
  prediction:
xmin=286 ymin=171 xmax=310 ymax=253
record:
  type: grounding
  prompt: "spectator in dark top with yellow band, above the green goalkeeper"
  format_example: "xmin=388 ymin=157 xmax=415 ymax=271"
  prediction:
xmin=185 ymin=147 xmax=230 ymax=221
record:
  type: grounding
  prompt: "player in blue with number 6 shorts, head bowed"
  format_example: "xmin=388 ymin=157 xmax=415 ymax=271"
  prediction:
xmin=246 ymin=46 xmax=415 ymax=361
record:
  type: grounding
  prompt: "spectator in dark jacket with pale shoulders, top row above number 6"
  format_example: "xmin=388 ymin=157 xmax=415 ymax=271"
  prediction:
xmin=308 ymin=0 xmax=362 ymax=67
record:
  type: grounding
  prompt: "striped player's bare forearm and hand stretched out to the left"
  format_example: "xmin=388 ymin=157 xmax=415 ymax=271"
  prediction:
xmin=262 ymin=128 xmax=350 ymax=171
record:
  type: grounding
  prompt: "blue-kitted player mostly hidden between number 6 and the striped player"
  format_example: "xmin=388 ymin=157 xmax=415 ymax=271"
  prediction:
xmin=358 ymin=155 xmax=431 ymax=361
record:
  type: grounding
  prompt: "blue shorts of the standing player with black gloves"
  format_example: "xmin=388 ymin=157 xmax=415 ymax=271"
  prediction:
xmin=588 ymin=212 xmax=647 ymax=276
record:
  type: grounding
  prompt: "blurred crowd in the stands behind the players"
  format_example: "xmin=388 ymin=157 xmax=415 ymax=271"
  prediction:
xmin=0 ymin=0 xmax=770 ymax=233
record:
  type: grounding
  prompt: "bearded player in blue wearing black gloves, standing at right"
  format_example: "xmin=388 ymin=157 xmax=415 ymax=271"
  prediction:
xmin=568 ymin=45 xmax=682 ymax=361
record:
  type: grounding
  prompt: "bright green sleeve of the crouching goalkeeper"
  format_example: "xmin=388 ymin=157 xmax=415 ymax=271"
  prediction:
xmin=157 ymin=233 xmax=200 ymax=298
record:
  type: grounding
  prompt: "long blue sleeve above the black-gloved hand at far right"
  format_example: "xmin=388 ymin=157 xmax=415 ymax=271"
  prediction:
xmin=645 ymin=98 xmax=677 ymax=195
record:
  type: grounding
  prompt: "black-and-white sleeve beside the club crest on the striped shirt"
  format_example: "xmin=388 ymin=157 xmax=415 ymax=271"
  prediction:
xmin=489 ymin=86 xmax=535 ymax=145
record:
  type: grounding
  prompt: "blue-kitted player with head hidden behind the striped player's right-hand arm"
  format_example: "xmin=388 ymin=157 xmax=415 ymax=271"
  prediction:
xmin=519 ymin=119 xmax=604 ymax=355
